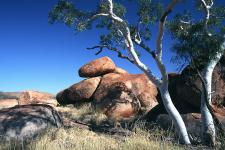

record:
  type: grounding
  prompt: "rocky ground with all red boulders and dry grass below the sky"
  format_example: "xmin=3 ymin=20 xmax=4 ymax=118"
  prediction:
xmin=0 ymin=57 xmax=225 ymax=149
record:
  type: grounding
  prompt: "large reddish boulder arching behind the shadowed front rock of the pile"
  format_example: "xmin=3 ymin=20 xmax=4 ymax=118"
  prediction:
xmin=94 ymin=73 xmax=158 ymax=109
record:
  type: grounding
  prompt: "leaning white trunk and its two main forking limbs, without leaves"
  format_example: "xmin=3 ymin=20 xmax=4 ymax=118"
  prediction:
xmin=100 ymin=0 xmax=191 ymax=144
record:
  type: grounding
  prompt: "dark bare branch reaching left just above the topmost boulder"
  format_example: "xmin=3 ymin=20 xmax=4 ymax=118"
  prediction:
xmin=87 ymin=45 xmax=134 ymax=63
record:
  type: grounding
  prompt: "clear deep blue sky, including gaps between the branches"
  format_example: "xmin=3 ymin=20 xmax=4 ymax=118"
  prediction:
xmin=0 ymin=0 xmax=225 ymax=93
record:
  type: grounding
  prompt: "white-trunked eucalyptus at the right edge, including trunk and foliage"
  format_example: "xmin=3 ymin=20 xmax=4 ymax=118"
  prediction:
xmin=169 ymin=0 xmax=225 ymax=145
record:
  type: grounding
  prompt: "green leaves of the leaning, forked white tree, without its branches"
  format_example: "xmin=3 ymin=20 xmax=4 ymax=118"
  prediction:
xmin=49 ymin=0 xmax=162 ymax=54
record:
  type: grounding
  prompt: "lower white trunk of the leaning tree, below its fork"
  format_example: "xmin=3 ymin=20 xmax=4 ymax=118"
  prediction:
xmin=160 ymin=84 xmax=191 ymax=144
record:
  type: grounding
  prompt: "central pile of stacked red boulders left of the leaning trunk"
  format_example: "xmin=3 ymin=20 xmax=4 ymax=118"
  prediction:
xmin=56 ymin=57 xmax=158 ymax=121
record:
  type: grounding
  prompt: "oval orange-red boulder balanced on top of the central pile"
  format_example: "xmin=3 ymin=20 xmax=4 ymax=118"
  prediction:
xmin=79 ymin=57 xmax=116 ymax=77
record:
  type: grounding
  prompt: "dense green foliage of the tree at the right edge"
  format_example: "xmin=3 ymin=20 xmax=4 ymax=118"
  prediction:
xmin=168 ymin=6 xmax=225 ymax=68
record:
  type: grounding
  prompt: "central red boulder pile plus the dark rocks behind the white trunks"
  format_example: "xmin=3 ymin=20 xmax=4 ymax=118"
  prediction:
xmin=57 ymin=57 xmax=225 ymax=125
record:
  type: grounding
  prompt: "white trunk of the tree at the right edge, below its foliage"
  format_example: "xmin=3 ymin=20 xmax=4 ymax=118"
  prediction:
xmin=201 ymin=52 xmax=223 ymax=146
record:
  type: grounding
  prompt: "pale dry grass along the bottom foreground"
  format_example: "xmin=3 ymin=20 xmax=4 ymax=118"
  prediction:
xmin=22 ymin=128 xmax=181 ymax=150
